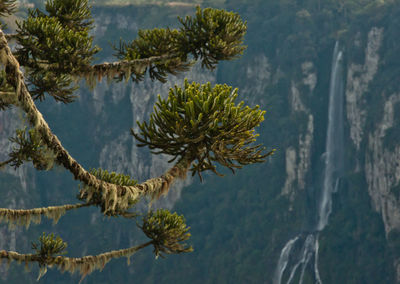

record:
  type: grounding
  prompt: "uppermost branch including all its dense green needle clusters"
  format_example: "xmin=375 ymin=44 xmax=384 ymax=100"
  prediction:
xmin=6 ymin=5 xmax=246 ymax=103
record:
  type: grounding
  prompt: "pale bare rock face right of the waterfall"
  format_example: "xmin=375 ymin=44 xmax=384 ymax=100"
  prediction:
xmin=346 ymin=27 xmax=400 ymax=239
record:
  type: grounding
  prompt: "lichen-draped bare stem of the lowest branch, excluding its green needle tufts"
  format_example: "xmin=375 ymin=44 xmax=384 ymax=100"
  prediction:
xmin=0 ymin=240 xmax=154 ymax=281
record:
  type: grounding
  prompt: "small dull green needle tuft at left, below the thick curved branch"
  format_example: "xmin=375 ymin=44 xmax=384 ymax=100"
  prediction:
xmin=7 ymin=128 xmax=56 ymax=170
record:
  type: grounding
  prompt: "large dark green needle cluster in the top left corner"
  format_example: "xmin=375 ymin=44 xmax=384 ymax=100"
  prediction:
xmin=16 ymin=0 xmax=99 ymax=103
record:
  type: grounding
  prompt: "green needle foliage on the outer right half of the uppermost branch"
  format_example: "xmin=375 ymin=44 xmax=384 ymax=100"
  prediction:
xmin=115 ymin=7 xmax=246 ymax=82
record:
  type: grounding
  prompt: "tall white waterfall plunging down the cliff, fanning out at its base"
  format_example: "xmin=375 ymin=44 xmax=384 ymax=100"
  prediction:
xmin=273 ymin=42 xmax=344 ymax=284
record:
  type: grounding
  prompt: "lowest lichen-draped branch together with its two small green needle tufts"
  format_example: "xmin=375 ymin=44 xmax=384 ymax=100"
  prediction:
xmin=0 ymin=210 xmax=193 ymax=281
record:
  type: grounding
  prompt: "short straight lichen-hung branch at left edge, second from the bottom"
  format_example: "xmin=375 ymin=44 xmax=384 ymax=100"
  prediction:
xmin=0 ymin=203 xmax=92 ymax=228
